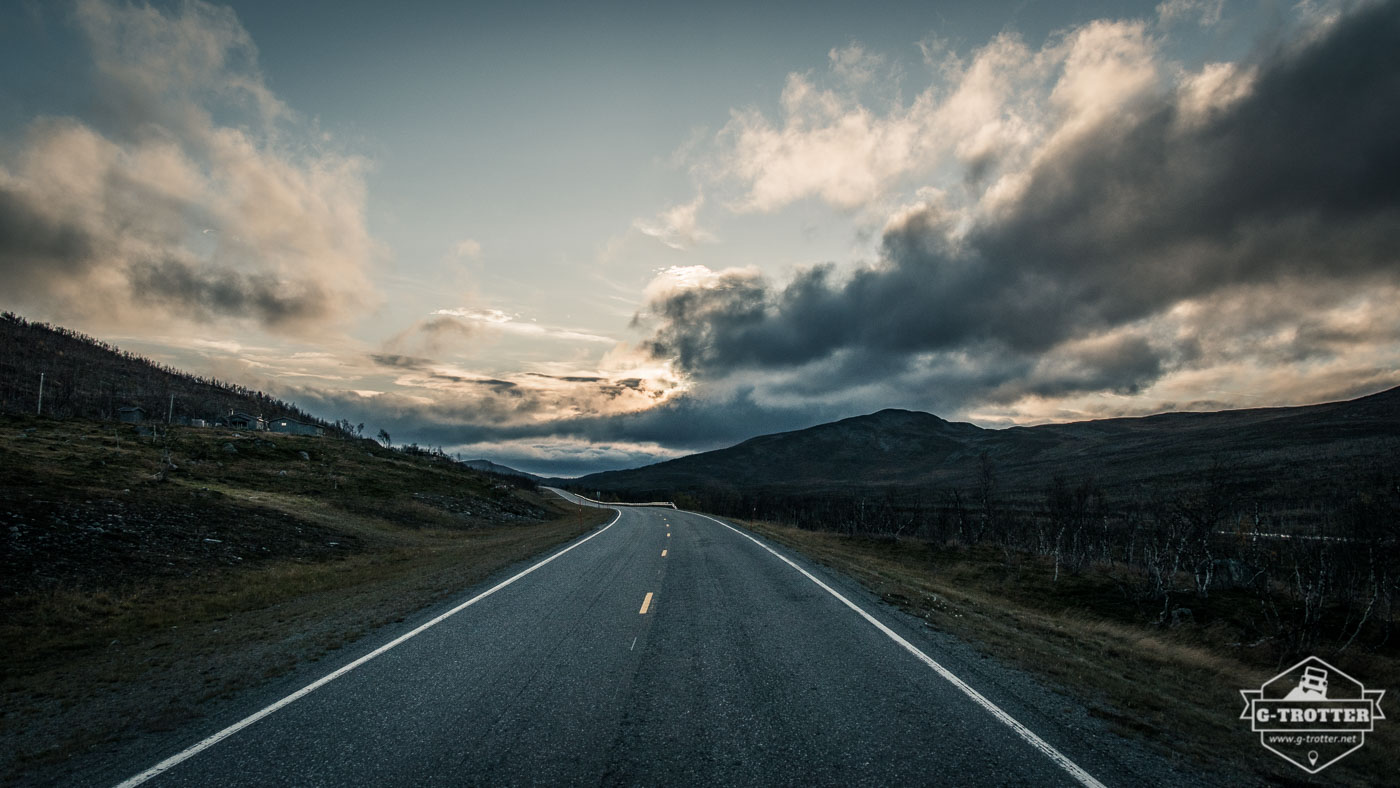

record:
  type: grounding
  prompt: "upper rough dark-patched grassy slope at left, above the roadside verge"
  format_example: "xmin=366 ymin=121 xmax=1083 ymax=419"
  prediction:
xmin=0 ymin=416 xmax=549 ymax=593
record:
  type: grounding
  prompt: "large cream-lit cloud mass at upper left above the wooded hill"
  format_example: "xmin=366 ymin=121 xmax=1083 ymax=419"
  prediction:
xmin=0 ymin=0 xmax=382 ymax=333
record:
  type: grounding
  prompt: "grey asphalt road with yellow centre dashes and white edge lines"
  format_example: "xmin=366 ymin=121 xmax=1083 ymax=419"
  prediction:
xmin=109 ymin=492 xmax=1173 ymax=785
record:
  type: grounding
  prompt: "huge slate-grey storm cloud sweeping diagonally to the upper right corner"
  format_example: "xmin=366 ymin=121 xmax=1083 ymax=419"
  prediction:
xmin=648 ymin=3 xmax=1400 ymax=396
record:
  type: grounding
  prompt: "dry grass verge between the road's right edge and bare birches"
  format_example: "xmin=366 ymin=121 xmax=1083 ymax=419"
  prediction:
xmin=745 ymin=522 xmax=1400 ymax=785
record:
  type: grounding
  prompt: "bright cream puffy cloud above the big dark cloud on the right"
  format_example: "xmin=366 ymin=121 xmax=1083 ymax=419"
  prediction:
xmin=700 ymin=21 xmax=1163 ymax=213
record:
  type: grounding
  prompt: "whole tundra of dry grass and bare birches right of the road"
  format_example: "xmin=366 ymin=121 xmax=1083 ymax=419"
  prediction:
xmin=678 ymin=452 xmax=1400 ymax=784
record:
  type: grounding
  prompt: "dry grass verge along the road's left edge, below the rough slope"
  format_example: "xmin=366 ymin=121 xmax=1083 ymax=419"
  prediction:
xmin=0 ymin=509 xmax=612 ymax=781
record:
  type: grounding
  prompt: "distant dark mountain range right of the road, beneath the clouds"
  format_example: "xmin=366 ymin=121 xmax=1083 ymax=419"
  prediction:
xmin=570 ymin=388 xmax=1400 ymax=498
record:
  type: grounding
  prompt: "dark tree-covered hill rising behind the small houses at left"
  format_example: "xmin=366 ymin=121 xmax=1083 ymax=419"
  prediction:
xmin=0 ymin=312 xmax=336 ymax=430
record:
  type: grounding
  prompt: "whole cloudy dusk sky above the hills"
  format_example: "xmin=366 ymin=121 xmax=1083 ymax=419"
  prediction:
xmin=0 ymin=0 xmax=1400 ymax=474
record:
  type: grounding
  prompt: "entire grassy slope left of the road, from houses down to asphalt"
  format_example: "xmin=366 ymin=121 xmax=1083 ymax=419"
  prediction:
xmin=0 ymin=416 xmax=612 ymax=784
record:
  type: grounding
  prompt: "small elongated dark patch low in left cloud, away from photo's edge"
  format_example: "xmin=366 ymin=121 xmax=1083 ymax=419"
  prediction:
xmin=127 ymin=260 xmax=329 ymax=326
